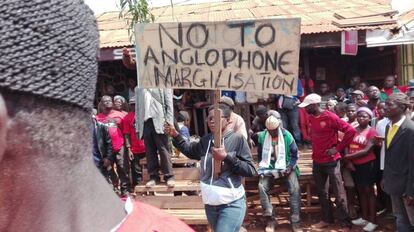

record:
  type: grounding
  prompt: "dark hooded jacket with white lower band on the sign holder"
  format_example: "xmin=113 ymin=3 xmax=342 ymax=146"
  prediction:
xmin=173 ymin=131 xmax=256 ymax=205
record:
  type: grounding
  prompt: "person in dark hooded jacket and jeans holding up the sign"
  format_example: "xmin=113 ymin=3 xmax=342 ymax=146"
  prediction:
xmin=164 ymin=104 xmax=256 ymax=232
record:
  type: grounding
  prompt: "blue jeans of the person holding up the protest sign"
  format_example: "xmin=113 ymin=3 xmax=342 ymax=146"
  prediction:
xmin=204 ymin=197 xmax=246 ymax=232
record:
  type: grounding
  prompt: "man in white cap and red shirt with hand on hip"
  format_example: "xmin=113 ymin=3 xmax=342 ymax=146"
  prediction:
xmin=299 ymin=93 xmax=355 ymax=230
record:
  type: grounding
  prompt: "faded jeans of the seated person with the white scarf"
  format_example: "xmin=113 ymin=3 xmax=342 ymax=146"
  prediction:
xmin=259 ymin=170 xmax=300 ymax=225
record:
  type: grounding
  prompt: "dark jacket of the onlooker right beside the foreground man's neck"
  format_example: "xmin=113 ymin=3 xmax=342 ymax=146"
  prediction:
xmin=92 ymin=120 xmax=115 ymax=166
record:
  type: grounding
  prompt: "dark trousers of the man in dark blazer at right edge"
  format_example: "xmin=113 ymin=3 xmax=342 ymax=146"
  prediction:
xmin=391 ymin=196 xmax=414 ymax=232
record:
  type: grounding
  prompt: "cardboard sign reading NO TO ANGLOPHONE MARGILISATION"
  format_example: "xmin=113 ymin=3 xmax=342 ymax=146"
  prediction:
xmin=135 ymin=19 xmax=300 ymax=95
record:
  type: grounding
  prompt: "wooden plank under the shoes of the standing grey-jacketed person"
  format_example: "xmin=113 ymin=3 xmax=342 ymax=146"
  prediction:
xmin=135 ymin=180 xmax=200 ymax=194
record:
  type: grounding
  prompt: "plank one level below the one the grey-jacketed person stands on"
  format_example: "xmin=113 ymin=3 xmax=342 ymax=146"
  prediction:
xmin=137 ymin=196 xmax=204 ymax=209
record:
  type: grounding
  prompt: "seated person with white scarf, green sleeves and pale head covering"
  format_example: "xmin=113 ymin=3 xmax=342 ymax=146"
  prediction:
xmin=258 ymin=116 xmax=302 ymax=232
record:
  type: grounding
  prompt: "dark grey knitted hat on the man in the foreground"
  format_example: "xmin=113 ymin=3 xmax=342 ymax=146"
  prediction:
xmin=0 ymin=0 xmax=99 ymax=108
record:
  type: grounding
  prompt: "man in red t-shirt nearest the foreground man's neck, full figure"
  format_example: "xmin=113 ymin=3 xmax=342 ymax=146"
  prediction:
xmin=96 ymin=95 xmax=131 ymax=196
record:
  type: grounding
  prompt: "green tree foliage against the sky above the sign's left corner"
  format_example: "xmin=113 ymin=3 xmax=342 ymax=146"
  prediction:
xmin=119 ymin=0 xmax=155 ymax=41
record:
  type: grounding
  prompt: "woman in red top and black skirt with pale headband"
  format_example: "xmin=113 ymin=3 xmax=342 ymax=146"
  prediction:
xmin=344 ymin=107 xmax=378 ymax=231
